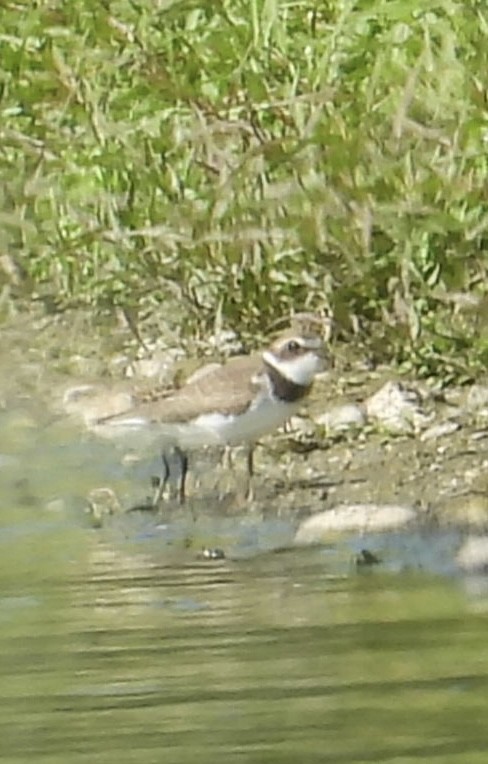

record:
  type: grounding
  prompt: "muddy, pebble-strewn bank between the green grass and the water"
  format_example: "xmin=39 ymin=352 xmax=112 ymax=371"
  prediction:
xmin=0 ymin=314 xmax=488 ymax=531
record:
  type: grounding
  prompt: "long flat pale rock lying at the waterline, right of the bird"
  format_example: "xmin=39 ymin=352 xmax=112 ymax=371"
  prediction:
xmin=295 ymin=504 xmax=417 ymax=544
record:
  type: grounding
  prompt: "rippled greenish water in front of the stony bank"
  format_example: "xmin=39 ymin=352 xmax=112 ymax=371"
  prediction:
xmin=0 ymin=336 xmax=488 ymax=764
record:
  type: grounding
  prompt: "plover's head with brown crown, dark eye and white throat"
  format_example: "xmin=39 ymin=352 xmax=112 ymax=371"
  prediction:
xmin=263 ymin=332 xmax=332 ymax=387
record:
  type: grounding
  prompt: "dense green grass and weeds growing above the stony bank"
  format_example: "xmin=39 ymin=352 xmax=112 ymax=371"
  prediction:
xmin=0 ymin=0 xmax=488 ymax=375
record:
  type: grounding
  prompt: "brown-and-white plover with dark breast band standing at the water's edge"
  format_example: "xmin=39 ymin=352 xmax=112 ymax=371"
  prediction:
xmin=92 ymin=330 xmax=330 ymax=504
